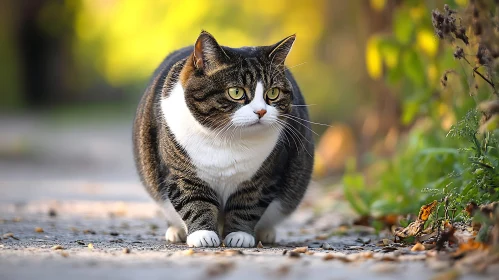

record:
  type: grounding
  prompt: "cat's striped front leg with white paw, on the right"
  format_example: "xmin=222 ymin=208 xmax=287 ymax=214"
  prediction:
xmin=224 ymin=186 xmax=269 ymax=247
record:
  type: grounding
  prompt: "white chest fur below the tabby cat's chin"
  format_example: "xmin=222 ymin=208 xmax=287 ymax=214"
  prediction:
xmin=161 ymin=83 xmax=280 ymax=204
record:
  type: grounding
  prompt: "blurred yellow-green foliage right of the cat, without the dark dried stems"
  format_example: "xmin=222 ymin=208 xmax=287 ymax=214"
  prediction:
xmin=343 ymin=1 xmax=499 ymax=219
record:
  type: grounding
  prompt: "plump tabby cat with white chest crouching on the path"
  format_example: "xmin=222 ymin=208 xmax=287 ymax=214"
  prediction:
xmin=133 ymin=31 xmax=314 ymax=247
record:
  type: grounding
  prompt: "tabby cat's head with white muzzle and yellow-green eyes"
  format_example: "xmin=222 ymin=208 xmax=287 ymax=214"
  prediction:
xmin=180 ymin=31 xmax=295 ymax=136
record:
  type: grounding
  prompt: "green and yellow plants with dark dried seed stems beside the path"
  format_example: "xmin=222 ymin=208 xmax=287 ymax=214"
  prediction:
xmin=343 ymin=0 xmax=499 ymax=219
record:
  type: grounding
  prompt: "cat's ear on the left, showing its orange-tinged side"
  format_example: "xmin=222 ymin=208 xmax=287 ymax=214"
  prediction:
xmin=193 ymin=30 xmax=229 ymax=73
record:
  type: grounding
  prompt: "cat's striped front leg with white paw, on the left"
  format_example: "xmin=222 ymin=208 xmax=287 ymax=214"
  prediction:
xmin=166 ymin=177 xmax=220 ymax=247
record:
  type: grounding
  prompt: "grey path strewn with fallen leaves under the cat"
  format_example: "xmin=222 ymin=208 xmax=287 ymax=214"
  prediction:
xmin=0 ymin=116 xmax=499 ymax=280
